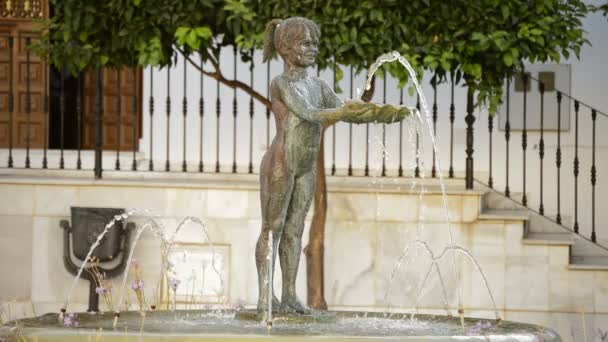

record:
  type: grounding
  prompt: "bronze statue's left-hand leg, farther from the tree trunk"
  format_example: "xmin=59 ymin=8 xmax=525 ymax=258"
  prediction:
xmin=255 ymin=158 xmax=294 ymax=312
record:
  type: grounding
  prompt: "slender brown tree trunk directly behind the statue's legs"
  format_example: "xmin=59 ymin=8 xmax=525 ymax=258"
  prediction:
xmin=304 ymin=134 xmax=327 ymax=310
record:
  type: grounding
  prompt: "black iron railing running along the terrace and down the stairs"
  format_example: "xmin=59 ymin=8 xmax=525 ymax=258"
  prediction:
xmin=0 ymin=36 xmax=608 ymax=248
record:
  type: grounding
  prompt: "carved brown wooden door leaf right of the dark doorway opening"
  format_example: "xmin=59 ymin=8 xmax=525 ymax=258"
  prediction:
xmin=83 ymin=68 xmax=142 ymax=151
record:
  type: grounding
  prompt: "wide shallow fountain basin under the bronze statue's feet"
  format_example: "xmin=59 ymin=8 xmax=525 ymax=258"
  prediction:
xmin=0 ymin=310 xmax=561 ymax=342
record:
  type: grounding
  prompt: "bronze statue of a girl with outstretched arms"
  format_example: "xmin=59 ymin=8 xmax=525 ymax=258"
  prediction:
xmin=255 ymin=17 xmax=412 ymax=313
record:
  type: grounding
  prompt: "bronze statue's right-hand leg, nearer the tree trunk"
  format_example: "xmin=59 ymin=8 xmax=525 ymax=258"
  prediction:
xmin=279 ymin=169 xmax=316 ymax=313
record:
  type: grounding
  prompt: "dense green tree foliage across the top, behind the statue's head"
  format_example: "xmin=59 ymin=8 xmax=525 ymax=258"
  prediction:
xmin=37 ymin=0 xmax=592 ymax=112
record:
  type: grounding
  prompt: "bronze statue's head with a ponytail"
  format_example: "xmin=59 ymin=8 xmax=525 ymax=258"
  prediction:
xmin=264 ymin=17 xmax=321 ymax=67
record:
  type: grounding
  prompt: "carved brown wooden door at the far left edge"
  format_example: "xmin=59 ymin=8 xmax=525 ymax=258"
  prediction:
xmin=0 ymin=0 xmax=48 ymax=148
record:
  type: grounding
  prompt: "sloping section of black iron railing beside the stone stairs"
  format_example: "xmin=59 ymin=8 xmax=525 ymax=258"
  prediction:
xmin=480 ymin=73 xmax=608 ymax=247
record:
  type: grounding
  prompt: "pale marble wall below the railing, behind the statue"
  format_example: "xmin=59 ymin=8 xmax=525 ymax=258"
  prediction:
xmin=0 ymin=177 xmax=608 ymax=339
